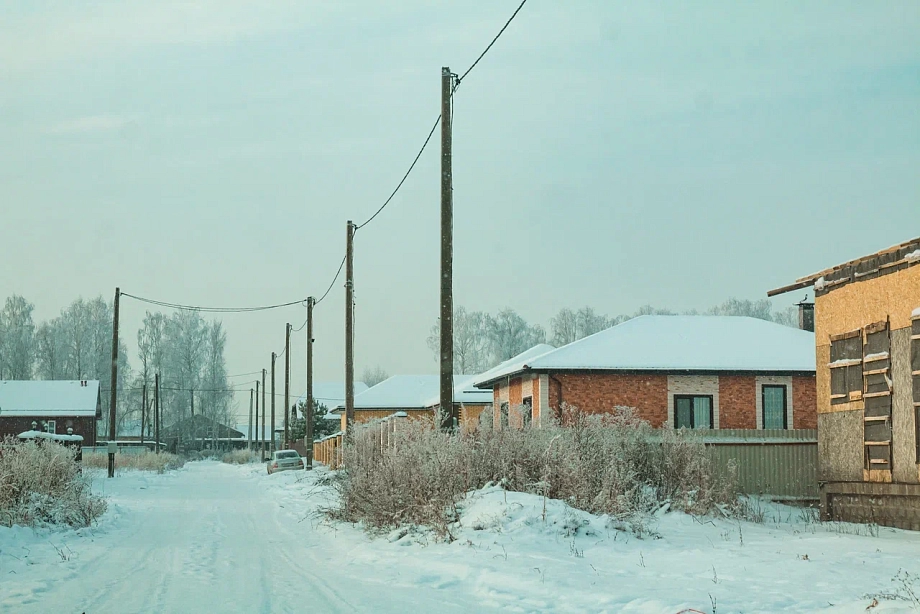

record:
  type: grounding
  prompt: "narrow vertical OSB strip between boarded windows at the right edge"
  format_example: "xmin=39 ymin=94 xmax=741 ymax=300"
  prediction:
xmin=891 ymin=328 xmax=920 ymax=484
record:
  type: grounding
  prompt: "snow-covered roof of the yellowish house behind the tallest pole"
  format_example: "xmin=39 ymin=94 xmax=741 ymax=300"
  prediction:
xmin=333 ymin=375 xmax=492 ymax=414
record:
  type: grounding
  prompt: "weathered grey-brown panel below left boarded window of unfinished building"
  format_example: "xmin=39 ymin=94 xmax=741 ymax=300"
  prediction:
xmin=818 ymin=410 xmax=863 ymax=482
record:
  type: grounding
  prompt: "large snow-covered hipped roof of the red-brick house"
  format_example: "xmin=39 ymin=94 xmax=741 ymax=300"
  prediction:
xmin=476 ymin=316 xmax=815 ymax=386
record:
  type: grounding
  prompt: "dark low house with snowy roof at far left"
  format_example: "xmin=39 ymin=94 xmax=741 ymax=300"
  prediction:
xmin=0 ymin=380 xmax=102 ymax=446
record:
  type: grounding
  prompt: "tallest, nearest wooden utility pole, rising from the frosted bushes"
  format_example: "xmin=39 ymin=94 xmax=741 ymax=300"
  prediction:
xmin=440 ymin=66 xmax=459 ymax=430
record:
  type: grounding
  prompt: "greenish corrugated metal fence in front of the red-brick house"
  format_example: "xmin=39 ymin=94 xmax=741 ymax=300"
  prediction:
xmin=702 ymin=429 xmax=818 ymax=501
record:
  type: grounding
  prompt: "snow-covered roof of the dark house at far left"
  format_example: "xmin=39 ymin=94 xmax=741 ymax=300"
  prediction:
xmin=0 ymin=380 xmax=99 ymax=417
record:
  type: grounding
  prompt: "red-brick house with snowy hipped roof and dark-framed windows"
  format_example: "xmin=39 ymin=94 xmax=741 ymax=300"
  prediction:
xmin=475 ymin=316 xmax=816 ymax=429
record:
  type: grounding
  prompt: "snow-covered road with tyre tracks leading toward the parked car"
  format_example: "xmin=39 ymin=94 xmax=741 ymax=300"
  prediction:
xmin=0 ymin=462 xmax=468 ymax=614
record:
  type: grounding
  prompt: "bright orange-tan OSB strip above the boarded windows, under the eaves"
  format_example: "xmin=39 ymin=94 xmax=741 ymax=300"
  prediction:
xmin=815 ymin=266 xmax=920 ymax=342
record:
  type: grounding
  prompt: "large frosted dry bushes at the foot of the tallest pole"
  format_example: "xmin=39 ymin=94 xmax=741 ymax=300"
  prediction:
xmin=329 ymin=407 xmax=737 ymax=535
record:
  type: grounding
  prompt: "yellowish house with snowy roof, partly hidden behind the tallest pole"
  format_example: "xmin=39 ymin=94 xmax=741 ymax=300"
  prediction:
xmin=331 ymin=375 xmax=492 ymax=431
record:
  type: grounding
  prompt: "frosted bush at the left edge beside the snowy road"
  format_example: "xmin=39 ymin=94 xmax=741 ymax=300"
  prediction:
xmin=0 ymin=438 xmax=106 ymax=527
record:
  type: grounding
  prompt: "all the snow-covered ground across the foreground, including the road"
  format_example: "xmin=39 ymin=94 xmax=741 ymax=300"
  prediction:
xmin=0 ymin=462 xmax=920 ymax=614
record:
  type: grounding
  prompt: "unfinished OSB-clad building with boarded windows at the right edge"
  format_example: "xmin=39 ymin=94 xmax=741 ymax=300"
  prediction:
xmin=768 ymin=238 xmax=920 ymax=530
